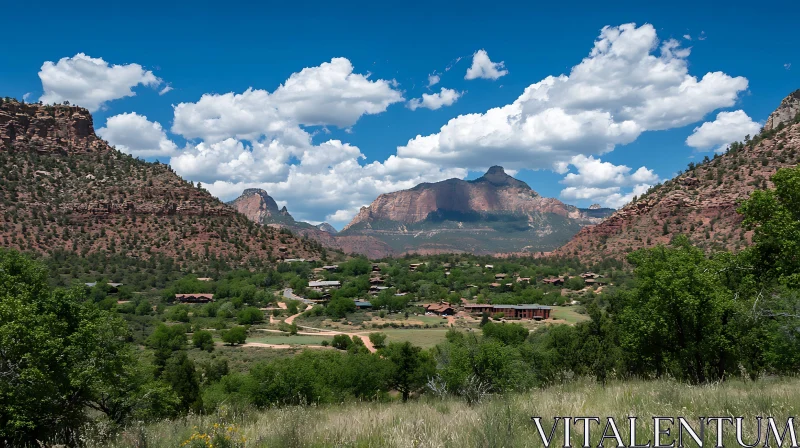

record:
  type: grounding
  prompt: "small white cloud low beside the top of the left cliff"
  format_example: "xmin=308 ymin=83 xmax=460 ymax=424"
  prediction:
xmin=97 ymin=112 xmax=178 ymax=158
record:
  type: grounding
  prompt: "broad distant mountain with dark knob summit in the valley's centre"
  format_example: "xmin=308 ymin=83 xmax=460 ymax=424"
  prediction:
xmin=339 ymin=166 xmax=613 ymax=254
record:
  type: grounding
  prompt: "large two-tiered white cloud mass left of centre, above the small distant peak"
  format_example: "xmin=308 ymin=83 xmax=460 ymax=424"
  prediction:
xmin=165 ymin=58 xmax=456 ymax=225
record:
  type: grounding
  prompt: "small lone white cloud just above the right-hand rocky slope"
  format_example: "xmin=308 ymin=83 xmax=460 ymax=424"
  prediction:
xmin=686 ymin=110 xmax=761 ymax=152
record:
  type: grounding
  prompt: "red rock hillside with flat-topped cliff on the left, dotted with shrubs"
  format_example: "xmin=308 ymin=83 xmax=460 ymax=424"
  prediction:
xmin=0 ymin=100 xmax=319 ymax=267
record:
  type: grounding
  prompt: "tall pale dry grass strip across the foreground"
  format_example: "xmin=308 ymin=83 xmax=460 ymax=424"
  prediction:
xmin=89 ymin=378 xmax=800 ymax=448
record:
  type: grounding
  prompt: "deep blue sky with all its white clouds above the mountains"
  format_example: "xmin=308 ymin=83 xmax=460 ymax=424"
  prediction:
xmin=0 ymin=1 xmax=800 ymax=227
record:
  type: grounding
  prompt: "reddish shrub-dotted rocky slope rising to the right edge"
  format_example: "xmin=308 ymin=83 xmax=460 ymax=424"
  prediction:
xmin=554 ymin=91 xmax=800 ymax=261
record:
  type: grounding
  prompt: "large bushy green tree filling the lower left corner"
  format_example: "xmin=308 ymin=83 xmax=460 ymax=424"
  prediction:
xmin=0 ymin=250 xmax=141 ymax=446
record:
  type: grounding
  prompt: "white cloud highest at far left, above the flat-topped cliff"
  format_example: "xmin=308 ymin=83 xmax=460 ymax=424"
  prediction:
xmin=39 ymin=53 xmax=162 ymax=112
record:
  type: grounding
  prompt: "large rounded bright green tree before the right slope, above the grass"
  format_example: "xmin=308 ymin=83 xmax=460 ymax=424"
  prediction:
xmin=619 ymin=236 xmax=741 ymax=383
